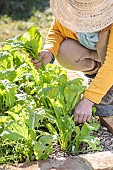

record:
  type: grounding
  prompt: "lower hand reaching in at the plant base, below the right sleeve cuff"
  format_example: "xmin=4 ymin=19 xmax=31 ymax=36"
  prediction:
xmin=74 ymin=97 xmax=94 ymax=123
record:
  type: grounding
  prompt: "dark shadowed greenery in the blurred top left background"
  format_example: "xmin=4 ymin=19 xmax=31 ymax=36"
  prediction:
xmin=0 ymin=0 xmax=49 ymax=20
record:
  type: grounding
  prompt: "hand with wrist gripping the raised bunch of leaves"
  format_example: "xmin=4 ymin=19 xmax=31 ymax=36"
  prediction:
xmin=31 ymin=50 xmax=52 ymax=69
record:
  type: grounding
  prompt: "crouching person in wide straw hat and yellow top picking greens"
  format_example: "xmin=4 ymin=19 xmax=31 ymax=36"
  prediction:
xmin=32 ymin=0 xmax=113 ymax=123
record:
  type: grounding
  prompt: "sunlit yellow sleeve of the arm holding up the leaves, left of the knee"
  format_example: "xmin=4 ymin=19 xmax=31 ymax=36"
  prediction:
xmin=44 ymin=19 xmax=65 ymax=56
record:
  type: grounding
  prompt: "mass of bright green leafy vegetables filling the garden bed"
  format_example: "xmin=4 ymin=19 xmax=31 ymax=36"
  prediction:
xmin=0 ymin=26 xmax=99 ymax=163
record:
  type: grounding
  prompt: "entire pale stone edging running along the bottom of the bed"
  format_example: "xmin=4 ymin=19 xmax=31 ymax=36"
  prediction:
xmin=0 ymin=151 xmax=113 ymax=170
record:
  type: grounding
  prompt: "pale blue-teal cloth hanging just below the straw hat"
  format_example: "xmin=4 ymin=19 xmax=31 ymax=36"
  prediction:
xmin=78 ymin=32 xmax=99 ymax=50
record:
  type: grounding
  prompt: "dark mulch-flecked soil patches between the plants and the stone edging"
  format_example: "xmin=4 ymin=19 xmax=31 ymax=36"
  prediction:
xmin=49 ymin=123 xmax=113 ymax=159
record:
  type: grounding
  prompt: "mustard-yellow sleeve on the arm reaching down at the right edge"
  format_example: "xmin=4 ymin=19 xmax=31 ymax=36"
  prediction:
xmin=84 ymin=26 xmax=113 ymax=104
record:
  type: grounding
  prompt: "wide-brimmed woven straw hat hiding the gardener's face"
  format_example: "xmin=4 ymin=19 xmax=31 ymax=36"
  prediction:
xmin=50 ymin=0 xmax=113 ymax=32
